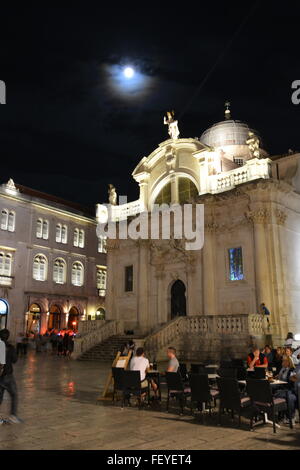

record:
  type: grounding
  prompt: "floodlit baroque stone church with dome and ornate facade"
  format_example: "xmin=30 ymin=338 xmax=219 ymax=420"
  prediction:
xmin=98 ymin=109 xmax=300 ymax=358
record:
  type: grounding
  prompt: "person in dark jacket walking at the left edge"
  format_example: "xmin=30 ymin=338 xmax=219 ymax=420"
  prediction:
xmin=0 ymin=329 xmax=21 ymax=424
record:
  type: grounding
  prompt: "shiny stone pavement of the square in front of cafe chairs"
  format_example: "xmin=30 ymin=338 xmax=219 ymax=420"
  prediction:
xmin=0 ymin=353 xmax=300 ymax=450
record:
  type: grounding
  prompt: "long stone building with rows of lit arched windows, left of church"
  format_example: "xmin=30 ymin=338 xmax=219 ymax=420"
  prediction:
xmin=0 ymin=180 xmax=106 ymax=338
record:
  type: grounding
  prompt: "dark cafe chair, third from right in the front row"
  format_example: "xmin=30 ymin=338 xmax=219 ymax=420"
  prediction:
xmin=190 ymin=374 xmax=219 ymax=416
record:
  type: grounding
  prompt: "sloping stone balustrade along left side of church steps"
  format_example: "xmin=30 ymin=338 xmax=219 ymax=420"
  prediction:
xmin=72 ymin=320 xmax=124 ymax=359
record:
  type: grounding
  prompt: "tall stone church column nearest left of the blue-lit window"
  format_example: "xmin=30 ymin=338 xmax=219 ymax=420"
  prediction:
xmin=202 ymin=223 xmax=218 ymax=315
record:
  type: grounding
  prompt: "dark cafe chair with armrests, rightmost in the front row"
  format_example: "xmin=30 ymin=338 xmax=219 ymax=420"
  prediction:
xmin=247 ymin=379 xmax=293 ymax=433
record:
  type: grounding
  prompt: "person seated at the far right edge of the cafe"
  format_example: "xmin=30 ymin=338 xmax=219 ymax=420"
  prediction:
xmin=274 ymin=356 xmax=297 ymax=424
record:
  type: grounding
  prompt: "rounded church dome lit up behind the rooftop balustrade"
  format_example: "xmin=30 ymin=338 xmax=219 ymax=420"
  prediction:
xmin=200 ymin=119 xmax=259 ymax=148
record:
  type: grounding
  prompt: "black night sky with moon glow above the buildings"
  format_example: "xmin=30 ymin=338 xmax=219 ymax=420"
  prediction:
xmin=0 ymin=1 xmax=300 ymax=206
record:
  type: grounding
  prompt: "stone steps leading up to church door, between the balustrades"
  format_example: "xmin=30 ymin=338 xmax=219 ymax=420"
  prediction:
xmin=78 ymin=335 xmax=142 ymax=362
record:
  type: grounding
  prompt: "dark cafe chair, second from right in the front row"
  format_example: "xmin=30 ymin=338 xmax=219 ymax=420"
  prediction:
xmin=217 ymin=377 xmax=251 ymax=426
